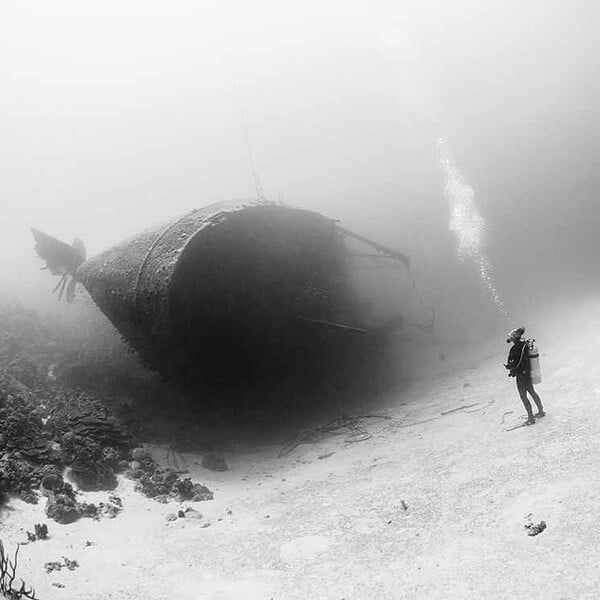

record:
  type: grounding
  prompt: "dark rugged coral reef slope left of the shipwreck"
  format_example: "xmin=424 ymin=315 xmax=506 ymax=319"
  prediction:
xmin=0 ymin=303 xmax=212 ymax=524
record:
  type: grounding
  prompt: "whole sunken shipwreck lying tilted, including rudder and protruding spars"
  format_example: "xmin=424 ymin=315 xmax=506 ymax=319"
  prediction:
xmin=32 ymin=200 xmax=409 ymax=386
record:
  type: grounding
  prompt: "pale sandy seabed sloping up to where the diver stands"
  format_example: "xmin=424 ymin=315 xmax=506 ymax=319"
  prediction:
xmin=0 ymin=302 xmax=600 ymax=600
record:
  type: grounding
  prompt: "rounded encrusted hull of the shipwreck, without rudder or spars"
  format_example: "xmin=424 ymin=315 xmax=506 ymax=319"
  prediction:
xmin=78 ymin=201 xmax=354 ymax=380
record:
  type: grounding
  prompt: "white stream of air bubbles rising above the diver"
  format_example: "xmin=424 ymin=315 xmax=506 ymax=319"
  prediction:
xmin=438 ymin=138 xmax=508 ymax=317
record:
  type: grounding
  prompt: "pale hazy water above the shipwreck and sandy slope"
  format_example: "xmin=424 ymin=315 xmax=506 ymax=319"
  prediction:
xmin=0 ymin=0 xmax=600 ymax=334
